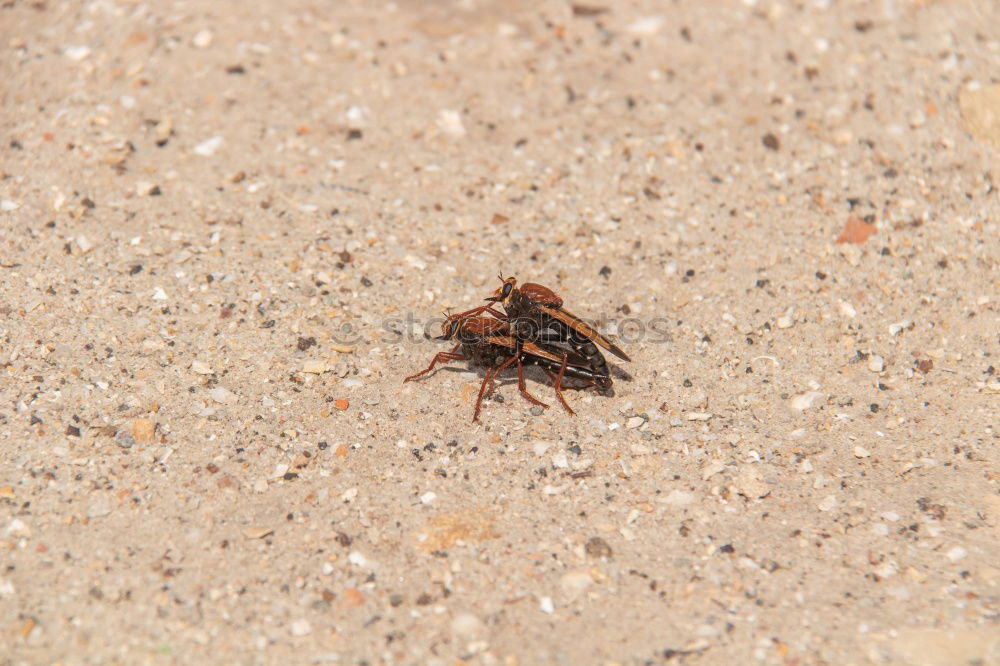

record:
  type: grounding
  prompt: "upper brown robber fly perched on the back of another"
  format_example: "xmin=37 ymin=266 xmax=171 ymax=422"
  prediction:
xmin=486 ymin=275 xmax=632 ymax=376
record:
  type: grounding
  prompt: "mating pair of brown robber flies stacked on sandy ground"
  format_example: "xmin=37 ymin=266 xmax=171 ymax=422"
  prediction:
xmin=403 ymin=276 xmax=630 ymax=421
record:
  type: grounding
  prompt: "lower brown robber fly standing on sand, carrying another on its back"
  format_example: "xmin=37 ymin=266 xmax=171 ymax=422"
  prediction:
xmin=403 ymin=306 xmax=611 ymax=422
